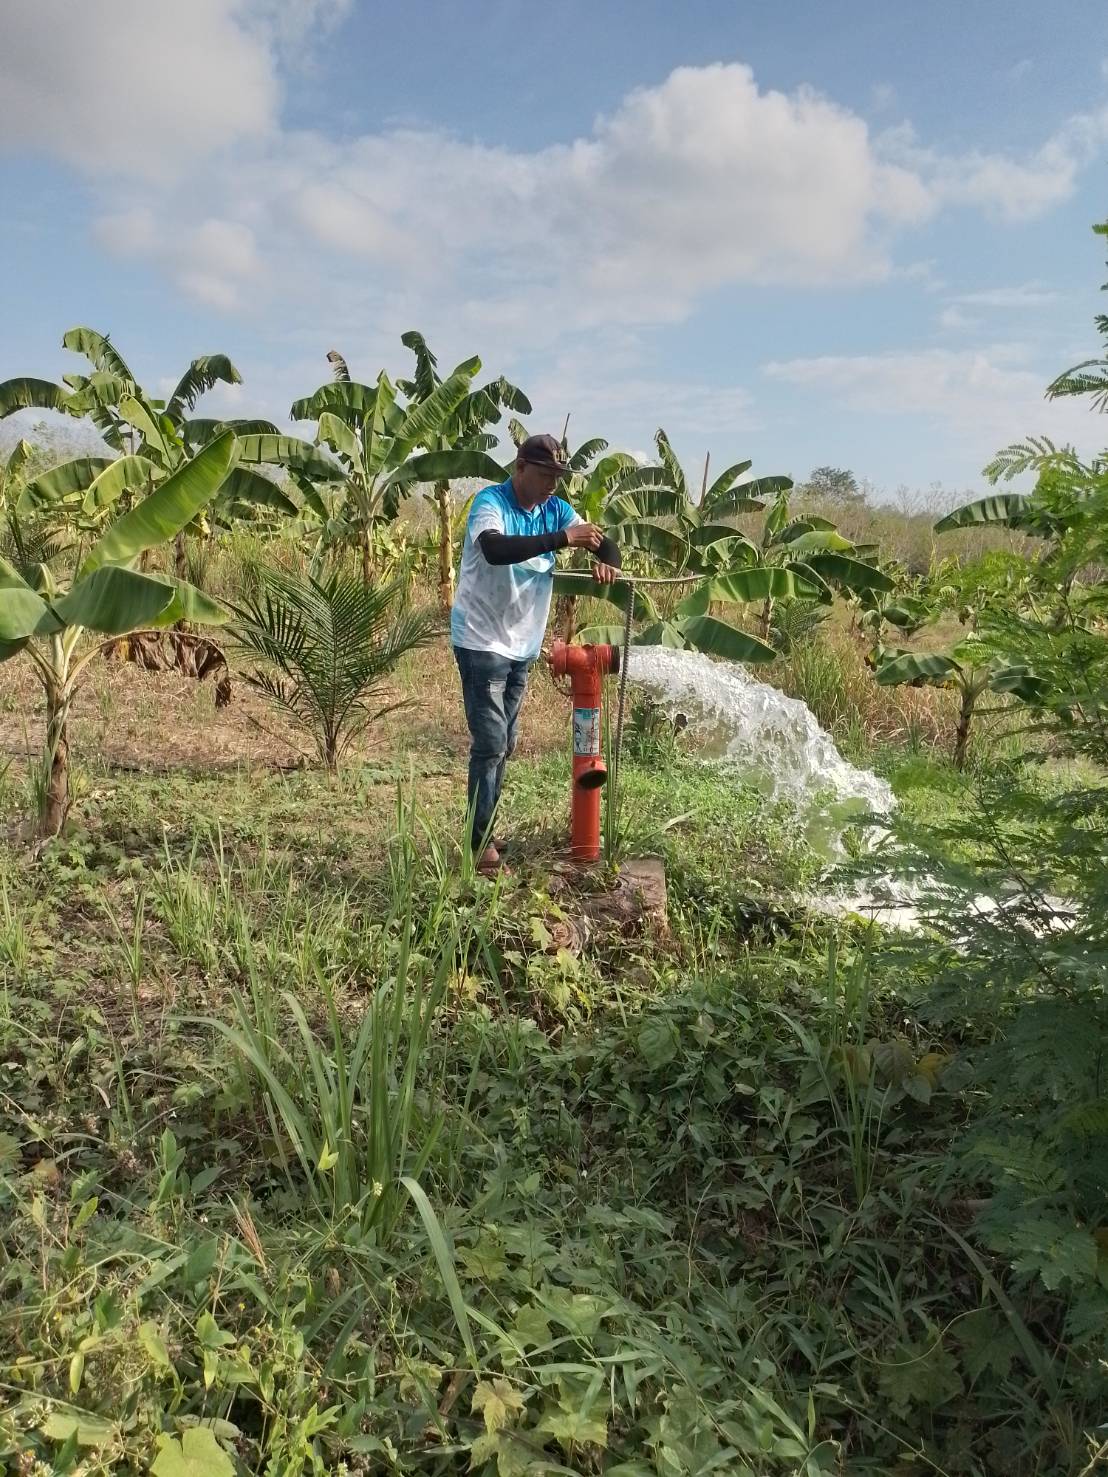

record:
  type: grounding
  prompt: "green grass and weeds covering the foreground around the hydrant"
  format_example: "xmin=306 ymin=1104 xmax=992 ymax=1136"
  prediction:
xmin=0 ymin=649 xmax=1098 ymax=1477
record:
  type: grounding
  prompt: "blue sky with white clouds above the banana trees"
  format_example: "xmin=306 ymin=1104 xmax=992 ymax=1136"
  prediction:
xmin=0 ymin=0 xmax=1108 ymax=490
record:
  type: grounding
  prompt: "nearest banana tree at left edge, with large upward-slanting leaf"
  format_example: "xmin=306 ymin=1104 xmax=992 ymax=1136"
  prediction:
xmin=0 ymin=431 xmax=238 ymax=836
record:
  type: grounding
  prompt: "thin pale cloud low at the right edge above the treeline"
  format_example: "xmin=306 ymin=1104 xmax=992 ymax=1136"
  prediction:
xmin=764 ymin=344 xmax=1104 ymax=465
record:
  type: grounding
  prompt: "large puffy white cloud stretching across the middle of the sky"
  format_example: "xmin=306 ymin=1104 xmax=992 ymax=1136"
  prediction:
xmin=76 ymin=65 xmax=963 ymax=331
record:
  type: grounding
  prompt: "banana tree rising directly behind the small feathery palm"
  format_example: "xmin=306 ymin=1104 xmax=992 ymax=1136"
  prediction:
xmin=290 ymin=350 xmax=504 ymax=583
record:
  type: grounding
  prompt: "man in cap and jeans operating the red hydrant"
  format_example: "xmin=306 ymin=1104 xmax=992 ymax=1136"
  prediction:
xmin=451 ymin=436 xmax=620 ymax=871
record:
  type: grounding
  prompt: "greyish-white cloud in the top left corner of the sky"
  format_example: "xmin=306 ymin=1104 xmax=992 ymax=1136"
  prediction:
xmin=0 ymin=0 xmax=278 ymax=182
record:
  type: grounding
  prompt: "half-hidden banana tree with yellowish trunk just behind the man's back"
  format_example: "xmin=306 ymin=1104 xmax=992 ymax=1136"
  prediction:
xmin=395 ymin=329 xmax=530 ymax=610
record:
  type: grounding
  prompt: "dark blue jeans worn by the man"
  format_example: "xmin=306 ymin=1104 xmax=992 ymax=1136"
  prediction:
xmin=454 ymin=647 xmax=532 ymax=851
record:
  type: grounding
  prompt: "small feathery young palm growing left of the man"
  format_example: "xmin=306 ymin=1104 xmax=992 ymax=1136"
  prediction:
xmin=235 ymin=570 xmax=437 ymax=772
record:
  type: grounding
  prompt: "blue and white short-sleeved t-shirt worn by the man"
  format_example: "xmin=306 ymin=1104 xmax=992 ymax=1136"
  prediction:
xmin=451 ymin=477 xmax=581 ymax=662
